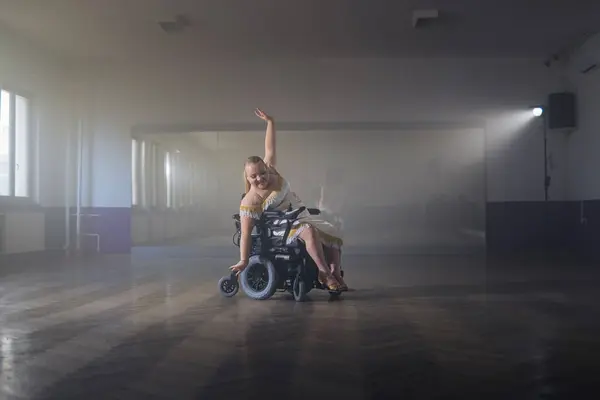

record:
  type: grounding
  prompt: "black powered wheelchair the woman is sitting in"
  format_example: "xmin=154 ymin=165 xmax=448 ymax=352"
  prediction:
xmin=219 ymin=207 xmax=344 ymax=302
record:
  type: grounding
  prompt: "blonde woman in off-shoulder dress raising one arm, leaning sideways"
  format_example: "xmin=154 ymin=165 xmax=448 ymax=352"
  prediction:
xmin=230 ymin=108 xmax=348 ymax=291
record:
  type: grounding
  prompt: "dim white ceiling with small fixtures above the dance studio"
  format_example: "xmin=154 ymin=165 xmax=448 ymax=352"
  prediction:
xmin=0 ymin=0 xmax=600 ymax=61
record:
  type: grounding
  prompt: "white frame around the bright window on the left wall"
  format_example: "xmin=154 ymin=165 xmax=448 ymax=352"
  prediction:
xmin=0 ymin=82 xmax=39 ymax=206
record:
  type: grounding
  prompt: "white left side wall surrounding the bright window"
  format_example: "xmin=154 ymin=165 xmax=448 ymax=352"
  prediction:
xmin=0 ymin=29 xmax=68 ymax=253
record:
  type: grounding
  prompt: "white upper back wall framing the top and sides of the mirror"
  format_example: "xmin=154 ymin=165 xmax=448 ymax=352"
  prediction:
xmin=86 ymin=59 xmax=566 ymax=207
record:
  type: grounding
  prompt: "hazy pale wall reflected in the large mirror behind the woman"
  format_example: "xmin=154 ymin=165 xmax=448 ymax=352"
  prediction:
xmin=200 ymin=127 xmax=486 ymax=252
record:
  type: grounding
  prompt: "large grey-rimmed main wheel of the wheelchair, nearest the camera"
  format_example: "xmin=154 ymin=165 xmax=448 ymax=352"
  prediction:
xmin=239 ymin=255 xmax=278 ymax=300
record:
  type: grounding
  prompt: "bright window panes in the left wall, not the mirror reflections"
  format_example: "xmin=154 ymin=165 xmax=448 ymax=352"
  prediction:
xmin=0 ymin=90 xmax=31 ymax=197
